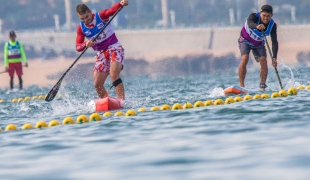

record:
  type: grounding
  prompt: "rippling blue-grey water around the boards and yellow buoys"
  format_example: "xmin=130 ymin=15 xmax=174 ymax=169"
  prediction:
xmin=0 ymin=66 xmax=310 ymax=179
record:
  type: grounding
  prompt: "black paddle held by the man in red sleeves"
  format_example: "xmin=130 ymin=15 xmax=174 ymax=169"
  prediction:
xmin=45 ymin=6 xmax=123 ymax=102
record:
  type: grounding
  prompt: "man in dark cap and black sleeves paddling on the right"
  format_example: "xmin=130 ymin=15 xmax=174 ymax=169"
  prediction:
xmin=238 ymin=4 xmax=278 ymax=91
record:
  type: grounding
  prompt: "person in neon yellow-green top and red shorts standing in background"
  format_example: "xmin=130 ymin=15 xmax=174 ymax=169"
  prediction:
xmin=4 ymin=31 xmax=28 ymax=91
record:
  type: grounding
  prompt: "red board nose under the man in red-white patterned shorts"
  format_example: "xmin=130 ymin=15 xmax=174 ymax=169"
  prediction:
xmin=95 ymin=97 xmax=124 ymax=112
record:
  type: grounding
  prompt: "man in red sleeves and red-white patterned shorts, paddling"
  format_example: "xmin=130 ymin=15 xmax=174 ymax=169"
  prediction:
xmin=76 ymin=0 xmax=128 ymax=99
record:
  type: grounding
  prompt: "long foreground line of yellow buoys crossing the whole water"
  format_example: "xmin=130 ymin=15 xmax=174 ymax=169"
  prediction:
xmin=0 ymin=86 xmax=310 ymax=132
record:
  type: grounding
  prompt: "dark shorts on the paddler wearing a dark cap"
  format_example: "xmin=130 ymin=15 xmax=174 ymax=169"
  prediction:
xmin=238 ymin=36 xmax=267 ymax=62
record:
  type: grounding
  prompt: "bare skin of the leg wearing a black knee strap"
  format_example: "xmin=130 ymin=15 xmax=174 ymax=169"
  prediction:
xmin=110 ymin=62 xmax=125 ymax=99
